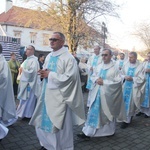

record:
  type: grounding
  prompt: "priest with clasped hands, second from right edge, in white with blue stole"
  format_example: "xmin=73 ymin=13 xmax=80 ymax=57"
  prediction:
xmin=121 ymin=52 xmax=145 ymax=129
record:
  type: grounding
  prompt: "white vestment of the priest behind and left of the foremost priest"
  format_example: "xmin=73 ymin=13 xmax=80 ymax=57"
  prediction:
xmin=17 ymin=55 xmax=41 ymax=118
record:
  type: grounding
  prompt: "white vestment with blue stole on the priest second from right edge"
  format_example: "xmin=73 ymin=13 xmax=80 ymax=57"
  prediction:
xmin=121 ymin=61 xmax=144 ymax=123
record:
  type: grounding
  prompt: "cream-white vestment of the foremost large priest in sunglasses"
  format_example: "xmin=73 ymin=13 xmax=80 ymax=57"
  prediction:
xmin=29 ymin=48 xmax=85 ymax=150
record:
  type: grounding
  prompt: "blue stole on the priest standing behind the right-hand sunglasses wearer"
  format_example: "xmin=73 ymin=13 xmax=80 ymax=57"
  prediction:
xmin=86 ymin=55 xmax=99 ymax=90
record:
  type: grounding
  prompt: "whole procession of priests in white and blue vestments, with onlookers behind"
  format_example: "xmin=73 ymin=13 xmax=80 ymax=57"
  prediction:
xmin=0 ymin=32 xmax=150 ymax=150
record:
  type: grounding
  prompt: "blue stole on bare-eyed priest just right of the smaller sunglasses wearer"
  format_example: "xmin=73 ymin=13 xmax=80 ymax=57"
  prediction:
xmin=123 ymin=68 xmax=136 ymax=113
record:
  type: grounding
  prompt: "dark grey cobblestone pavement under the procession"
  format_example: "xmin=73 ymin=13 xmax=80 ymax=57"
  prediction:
xmin=0 ymin=94 xmax=150 ymax=150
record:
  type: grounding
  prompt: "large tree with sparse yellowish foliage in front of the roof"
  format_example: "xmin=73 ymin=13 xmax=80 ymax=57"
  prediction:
xmin=17 ymin=0 xmax=119 ymax=51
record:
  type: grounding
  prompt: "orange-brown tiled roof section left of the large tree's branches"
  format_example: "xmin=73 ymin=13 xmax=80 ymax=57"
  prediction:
xmin=0 ymin=6 xmax=50 ymax=29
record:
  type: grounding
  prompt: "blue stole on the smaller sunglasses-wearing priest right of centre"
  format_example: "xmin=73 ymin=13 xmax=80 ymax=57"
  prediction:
xmin=86 ymin=69 xmax=107 ymax=128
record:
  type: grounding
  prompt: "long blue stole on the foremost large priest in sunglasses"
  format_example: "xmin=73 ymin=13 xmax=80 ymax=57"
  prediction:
xmin=41 ymin=56 xmax=58 ymax=132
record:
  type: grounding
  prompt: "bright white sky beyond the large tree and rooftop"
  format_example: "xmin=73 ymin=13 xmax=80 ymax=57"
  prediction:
xmin=1 ymin=0 xmax=150 ymax=50
